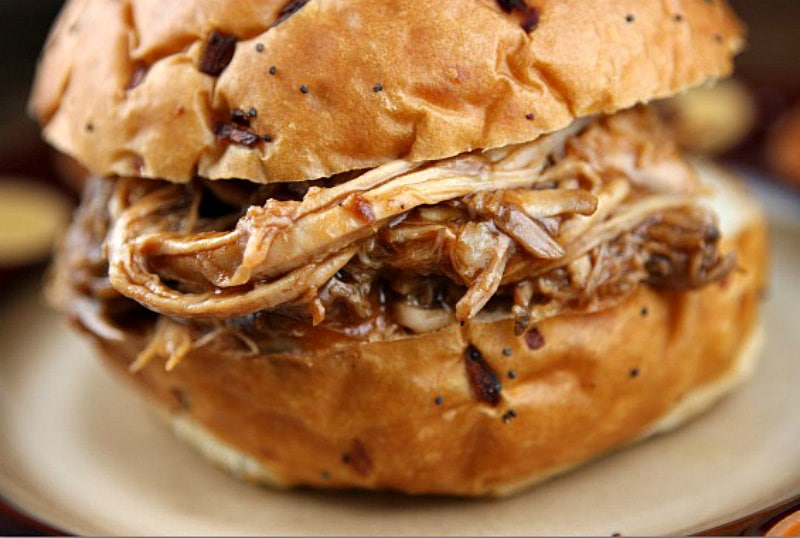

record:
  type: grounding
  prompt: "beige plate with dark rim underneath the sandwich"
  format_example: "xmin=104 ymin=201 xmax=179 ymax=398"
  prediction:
xmin=0 ymin=169 xmax=800 ymax=535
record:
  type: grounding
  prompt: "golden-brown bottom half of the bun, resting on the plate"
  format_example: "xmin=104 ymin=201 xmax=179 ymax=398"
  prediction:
xmin=84 ymin=164 xmax=767 ymax=495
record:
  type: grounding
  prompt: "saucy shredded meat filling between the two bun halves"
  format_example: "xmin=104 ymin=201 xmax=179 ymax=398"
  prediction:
xmin=53 ymin=108 xmax=734 ymax=363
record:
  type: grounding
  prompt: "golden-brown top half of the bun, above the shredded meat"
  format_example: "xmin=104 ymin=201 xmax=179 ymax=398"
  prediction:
xmin=30 ymin=0 xmax=743 ymax=183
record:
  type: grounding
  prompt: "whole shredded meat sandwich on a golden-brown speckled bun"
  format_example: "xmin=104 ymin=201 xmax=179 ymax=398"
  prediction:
xmin=31 ymin=0 xmax=765 ymax=495
